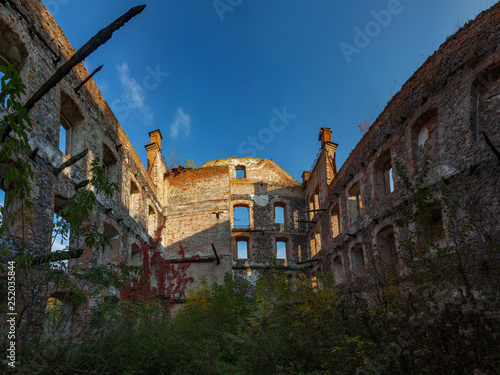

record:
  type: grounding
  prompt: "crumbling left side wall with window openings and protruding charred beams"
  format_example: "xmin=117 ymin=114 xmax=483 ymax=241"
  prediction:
xmin=0 ymin=0 xmax=162 ymax=280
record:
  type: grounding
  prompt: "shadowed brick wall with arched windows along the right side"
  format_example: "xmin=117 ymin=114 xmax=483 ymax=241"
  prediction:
xmin=303 ymin=4 xmax=500 ymax=282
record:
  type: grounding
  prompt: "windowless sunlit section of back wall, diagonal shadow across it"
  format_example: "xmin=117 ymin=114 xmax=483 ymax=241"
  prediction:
xmin=163 ymin=166 xmax=231 ymax=284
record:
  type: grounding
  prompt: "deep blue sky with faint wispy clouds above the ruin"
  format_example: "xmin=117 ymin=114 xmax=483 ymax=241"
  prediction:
xmin=43 ymin=0 xmax=496 ymax=181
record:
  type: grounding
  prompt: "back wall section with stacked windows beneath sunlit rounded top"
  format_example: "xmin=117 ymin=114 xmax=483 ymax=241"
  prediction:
xmin=202 ymin=157 xmax=307 ymax=284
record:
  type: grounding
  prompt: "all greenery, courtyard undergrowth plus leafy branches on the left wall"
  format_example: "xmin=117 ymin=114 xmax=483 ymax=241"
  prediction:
xmin=0 ymin=67 xmax=500 ymax=375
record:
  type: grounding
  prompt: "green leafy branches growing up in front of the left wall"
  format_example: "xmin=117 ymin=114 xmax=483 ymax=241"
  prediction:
xmin=0 ymin=65 xmax=144 ymax=372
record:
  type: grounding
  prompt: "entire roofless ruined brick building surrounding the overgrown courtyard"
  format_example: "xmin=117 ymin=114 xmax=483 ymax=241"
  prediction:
xmin=0 ymin=0 xmax=500 ymax=318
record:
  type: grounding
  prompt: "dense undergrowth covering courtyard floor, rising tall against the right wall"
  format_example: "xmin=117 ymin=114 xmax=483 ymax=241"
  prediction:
xmin=42 ymin=157 xmax=500 ymax=375
